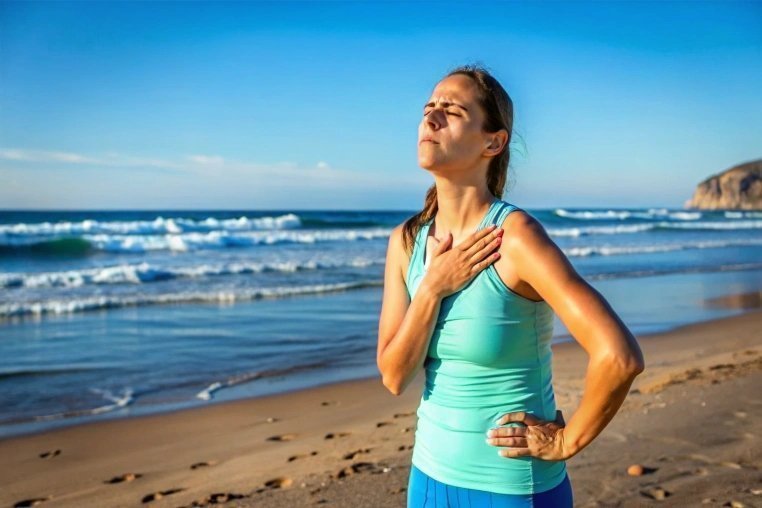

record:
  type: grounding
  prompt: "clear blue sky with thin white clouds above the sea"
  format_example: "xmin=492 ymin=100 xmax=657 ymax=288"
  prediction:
xmin=0 ymin=1 xmax=762 ymax=210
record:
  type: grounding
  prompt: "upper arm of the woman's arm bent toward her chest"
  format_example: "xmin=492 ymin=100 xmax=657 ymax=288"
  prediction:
xmin=376 ymin=224 xmax=410 ymax=363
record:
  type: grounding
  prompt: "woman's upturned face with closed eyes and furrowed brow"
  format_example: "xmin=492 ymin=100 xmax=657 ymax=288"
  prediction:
xmin=418 ymin=74 xmax=490 ymax=174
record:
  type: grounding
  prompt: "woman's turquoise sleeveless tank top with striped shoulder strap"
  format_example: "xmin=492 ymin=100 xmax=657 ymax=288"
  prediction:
xmin=407 ymin=199 xmax=566 ymax=494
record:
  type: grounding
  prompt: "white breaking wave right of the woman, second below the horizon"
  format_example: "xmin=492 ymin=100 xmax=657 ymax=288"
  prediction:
xmin=546 ymin=220 xmax=762 ymax=236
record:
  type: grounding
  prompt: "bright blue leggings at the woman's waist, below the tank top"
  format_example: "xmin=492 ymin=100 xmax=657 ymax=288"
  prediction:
xmin=407 ymin=464 xmax=574 ymax=508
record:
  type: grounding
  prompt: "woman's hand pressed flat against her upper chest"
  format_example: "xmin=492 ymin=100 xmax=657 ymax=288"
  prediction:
xmin=421 ymin=225 xmax=503 ymax=298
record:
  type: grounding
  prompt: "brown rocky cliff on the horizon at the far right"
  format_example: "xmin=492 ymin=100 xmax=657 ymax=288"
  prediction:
xmin=684 ymin=159 xmax=762 ymax=210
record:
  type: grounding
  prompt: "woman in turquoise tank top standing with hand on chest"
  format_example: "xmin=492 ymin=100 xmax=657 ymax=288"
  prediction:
xmin=377 ymin=66 xmax=644 ymax=507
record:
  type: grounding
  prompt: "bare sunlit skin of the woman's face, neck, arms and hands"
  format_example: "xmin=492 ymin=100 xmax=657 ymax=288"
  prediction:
xmin=377 ymin=75 xmax=645 ymax=460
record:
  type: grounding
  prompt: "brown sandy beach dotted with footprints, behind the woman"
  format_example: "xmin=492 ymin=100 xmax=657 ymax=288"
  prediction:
xmin=0 ymin=310 xmax=762 ymax=507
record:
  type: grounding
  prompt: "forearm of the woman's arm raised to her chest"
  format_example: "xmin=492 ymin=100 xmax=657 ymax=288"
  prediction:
xmin=378 ymin=283 xmax=442 ymax=395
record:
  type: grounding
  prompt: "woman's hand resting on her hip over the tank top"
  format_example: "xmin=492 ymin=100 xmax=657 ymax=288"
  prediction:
xmin=487 ymin=410 xmax=569 ymax=460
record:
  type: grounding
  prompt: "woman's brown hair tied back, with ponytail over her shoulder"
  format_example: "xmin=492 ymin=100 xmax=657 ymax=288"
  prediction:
xmin=402 ymin=64 xmax=513 ymax=255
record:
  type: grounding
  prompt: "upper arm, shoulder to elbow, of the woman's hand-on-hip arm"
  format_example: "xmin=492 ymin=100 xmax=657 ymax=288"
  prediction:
xmin=500 ymin=210 xmax=643 ymax=366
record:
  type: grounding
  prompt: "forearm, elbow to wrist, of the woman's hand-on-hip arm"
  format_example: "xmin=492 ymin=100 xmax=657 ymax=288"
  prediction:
xmin=563 ymin=357 xmax=642 ymax=458
